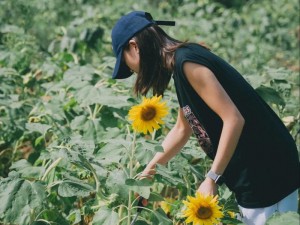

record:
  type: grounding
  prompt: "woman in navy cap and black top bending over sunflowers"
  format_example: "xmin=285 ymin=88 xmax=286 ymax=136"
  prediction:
xmin=112 ymin=11 xmax=299 ymax=225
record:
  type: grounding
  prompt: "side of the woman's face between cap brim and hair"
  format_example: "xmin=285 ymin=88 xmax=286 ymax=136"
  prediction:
xmin=123 ymin=40 xmax=140 ymax=73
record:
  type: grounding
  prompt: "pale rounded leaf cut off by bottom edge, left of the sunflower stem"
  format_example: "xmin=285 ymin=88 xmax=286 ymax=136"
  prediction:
xmin=92 ymin=207 xmax=119 ymax=225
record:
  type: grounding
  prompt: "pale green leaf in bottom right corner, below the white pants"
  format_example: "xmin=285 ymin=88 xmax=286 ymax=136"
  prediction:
xmin=266 ymin=212 xmax=300 ymax=225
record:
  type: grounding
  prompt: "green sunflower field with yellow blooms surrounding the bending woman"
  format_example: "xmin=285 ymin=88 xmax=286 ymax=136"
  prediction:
xmin=0 ymin=0 xmax=300 ymax=225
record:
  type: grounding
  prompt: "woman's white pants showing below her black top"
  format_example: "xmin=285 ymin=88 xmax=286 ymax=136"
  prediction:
xmin=238 ymin=190 xmax=298 ymax=225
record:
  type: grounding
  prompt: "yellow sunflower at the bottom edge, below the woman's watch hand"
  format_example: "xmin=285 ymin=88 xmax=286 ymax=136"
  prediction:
xmin=183 ymin=192 xmax=223 ymax=225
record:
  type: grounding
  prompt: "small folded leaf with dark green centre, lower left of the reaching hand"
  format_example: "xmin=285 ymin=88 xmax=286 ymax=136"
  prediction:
xmin=58 ymin=180 xmax=95 ymax=197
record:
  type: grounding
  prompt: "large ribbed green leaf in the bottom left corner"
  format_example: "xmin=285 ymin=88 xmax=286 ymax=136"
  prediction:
xmin=0 ymin=172 xmax=46 ymax=225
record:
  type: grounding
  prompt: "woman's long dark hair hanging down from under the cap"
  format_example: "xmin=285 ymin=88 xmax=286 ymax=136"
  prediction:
xmin=134 ymin=25 xmax=184 ymax=95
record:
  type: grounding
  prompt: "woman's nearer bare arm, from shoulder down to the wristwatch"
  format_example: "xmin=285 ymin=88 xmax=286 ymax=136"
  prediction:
xmin=184 ymin=62 xmax=245 ymax=193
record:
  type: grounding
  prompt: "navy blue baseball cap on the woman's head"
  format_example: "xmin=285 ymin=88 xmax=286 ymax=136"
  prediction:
xmin=111 ymin=11 xmax=175 ymax=79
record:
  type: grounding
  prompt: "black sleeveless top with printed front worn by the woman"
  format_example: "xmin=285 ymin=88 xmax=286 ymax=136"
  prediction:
xmin=173 ymin=44 xmax=300 ymax=208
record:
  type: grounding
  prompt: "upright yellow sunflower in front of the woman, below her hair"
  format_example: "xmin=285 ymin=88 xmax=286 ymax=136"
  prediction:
xmin=128 ymin=96 xmax=168 ymax=134
